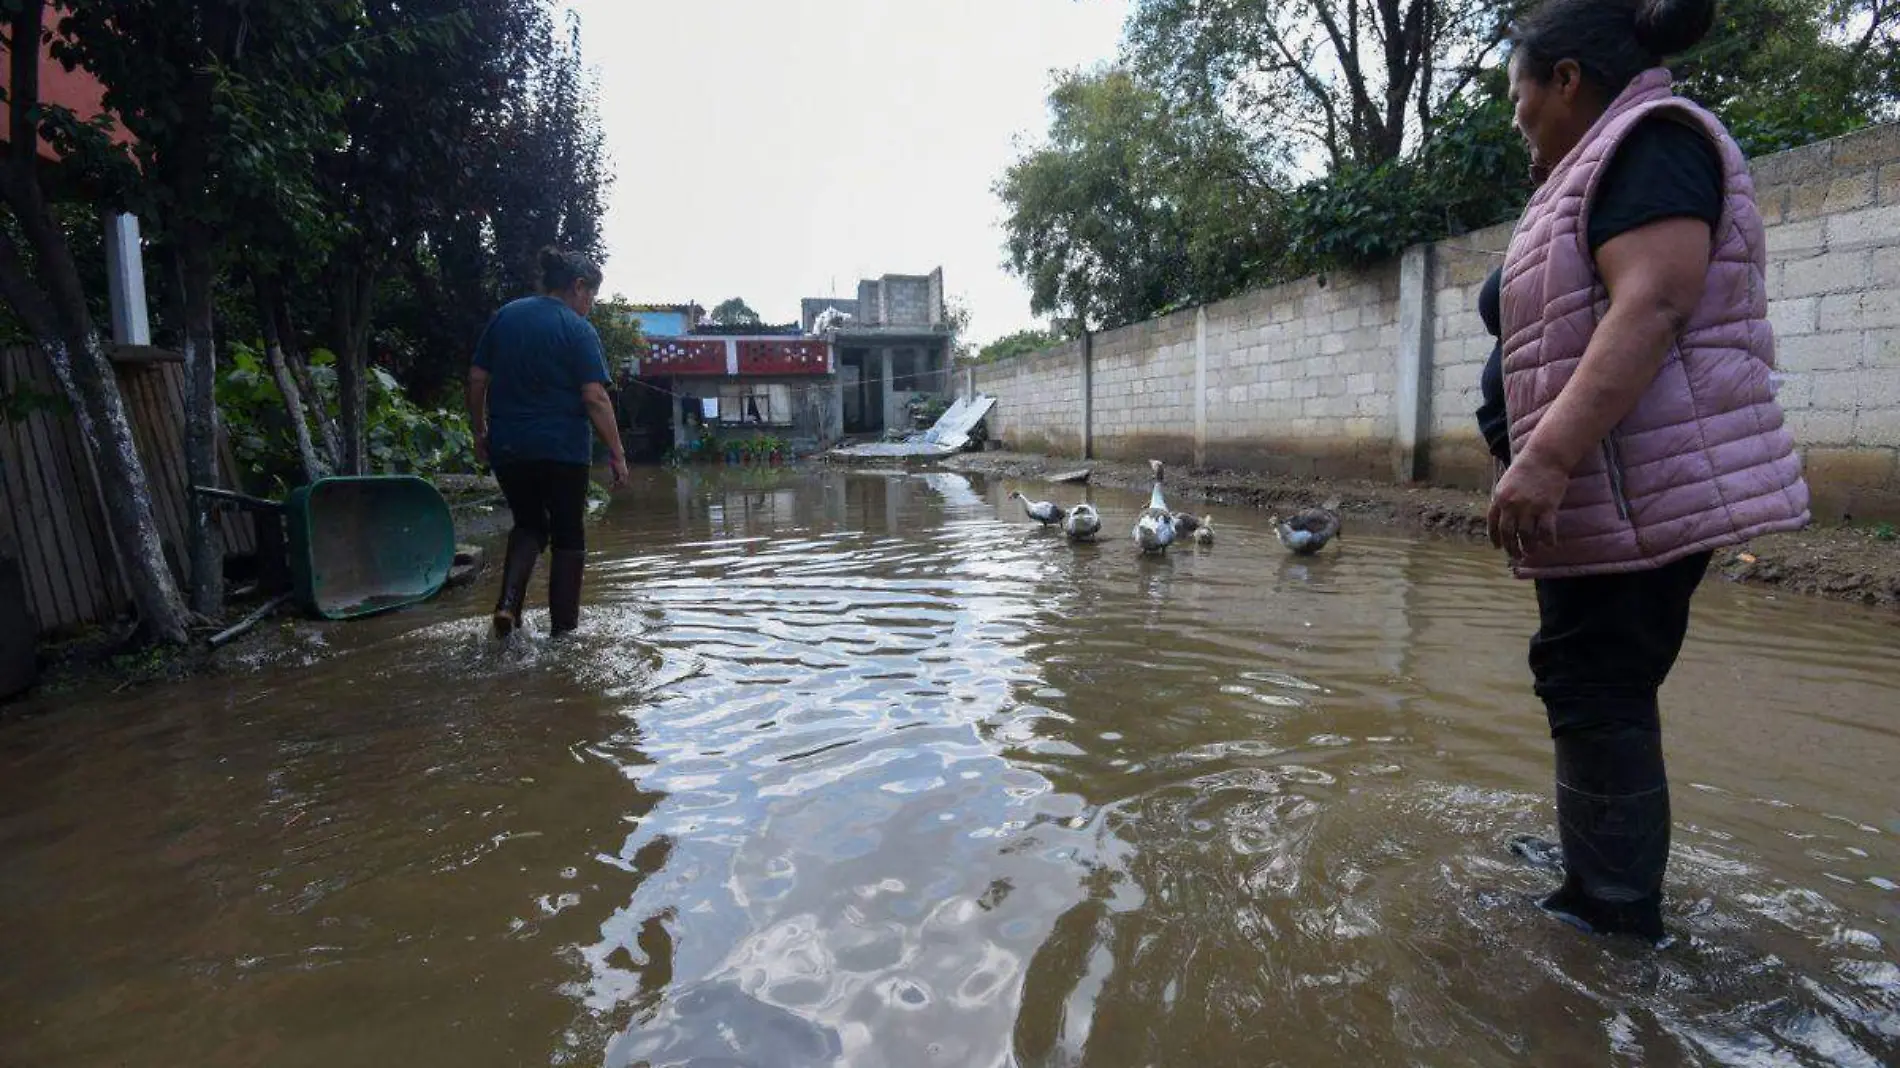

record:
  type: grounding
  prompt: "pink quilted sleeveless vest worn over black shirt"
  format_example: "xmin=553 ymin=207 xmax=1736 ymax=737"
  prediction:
xmin=1501 ymin=68 xmax=1809 ymax=578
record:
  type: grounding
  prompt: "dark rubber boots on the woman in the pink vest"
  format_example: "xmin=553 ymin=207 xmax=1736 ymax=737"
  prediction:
xmin=1539 ymin=726 xmax=1670 ymax=944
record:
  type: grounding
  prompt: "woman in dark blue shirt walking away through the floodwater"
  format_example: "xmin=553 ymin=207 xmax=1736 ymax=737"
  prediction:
xmin=467 ymin=249 xmax=627 ymax=637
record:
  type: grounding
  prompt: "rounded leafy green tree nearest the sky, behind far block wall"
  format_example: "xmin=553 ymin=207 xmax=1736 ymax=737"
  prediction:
xmin=996 ymin=68 xmax=1281 ymax=329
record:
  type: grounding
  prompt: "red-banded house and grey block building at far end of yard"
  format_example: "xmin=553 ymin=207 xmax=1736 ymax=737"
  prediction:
xmin=621 ymin=268 xmax=954 ymax=460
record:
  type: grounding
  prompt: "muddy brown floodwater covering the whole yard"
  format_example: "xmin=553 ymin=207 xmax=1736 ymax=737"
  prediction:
xmin=0 ymin=471 xmax=1900 ymax=1068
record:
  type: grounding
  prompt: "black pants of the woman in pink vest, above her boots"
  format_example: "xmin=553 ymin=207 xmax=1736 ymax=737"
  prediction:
xmin=1531 ymin=553 xmax=1714 ymax=737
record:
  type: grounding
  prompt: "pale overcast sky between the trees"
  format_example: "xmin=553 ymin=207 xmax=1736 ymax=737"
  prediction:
xmin=568 ymin=0 xmax=1129 ymax=342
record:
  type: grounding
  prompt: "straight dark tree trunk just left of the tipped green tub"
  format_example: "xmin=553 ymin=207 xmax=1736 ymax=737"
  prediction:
xmin=179 ymin=228 xmax=224 ymax=618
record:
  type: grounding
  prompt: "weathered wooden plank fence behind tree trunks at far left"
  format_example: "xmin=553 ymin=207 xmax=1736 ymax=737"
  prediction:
xmin=0 ymin=348 xmax=257 ymax=635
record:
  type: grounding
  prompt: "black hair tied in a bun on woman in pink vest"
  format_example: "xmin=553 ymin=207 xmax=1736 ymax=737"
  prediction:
xmin=1511 ymin=0 xmax=1716 ymax=97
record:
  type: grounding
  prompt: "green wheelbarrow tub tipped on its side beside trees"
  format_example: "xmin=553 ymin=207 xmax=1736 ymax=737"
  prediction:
xmin=283 ymin=475 xmax=456 ymax=620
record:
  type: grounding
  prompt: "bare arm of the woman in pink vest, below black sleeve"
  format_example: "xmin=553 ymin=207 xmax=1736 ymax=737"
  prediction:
xmin=1488 ymin=219 xmax=1710 ymax=549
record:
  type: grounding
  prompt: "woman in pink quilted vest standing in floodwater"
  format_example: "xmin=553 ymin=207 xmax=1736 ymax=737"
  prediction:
xmin=1486 ymin=0 xmax=1807 ymax=941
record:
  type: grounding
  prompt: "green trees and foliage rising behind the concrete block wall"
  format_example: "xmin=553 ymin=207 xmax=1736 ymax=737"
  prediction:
xmin=1003 ymin=0 xmax=1900 ymax=328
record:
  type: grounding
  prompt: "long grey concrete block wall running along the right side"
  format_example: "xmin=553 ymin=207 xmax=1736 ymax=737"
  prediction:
xmin=973 ymin=125 xmax=1900 ymax=521
